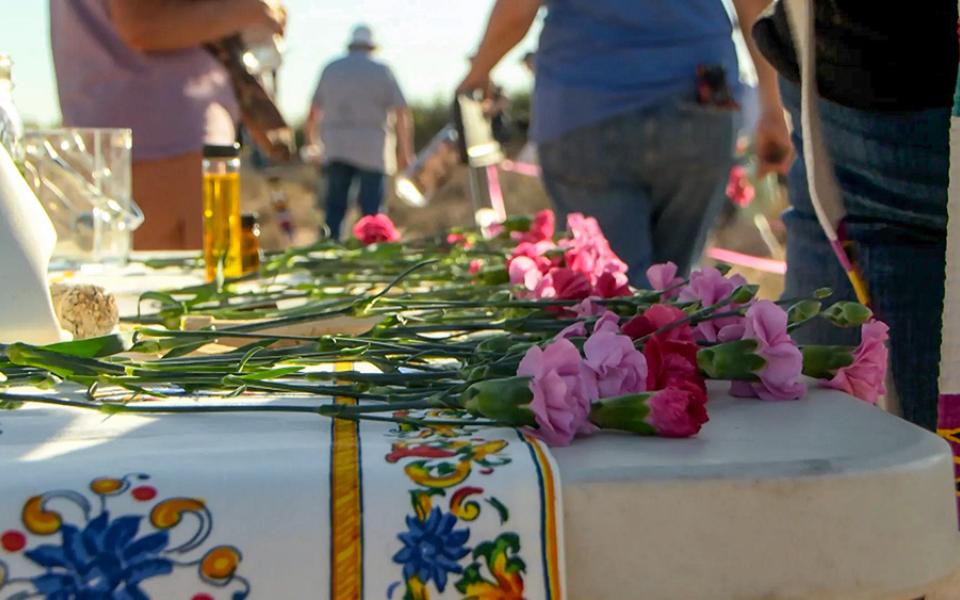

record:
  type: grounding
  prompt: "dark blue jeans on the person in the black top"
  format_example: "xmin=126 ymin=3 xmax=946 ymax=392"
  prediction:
xmin=781 ymin=81 xmax=950 ymax=431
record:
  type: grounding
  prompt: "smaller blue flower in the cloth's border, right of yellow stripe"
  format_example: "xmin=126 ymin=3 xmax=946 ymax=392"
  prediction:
xmin=393 ymin=507 xmax=470 ymax=592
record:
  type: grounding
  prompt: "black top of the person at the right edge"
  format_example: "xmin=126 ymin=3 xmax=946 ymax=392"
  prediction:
xmin=753 ymin=0 xmax=960 ymax=111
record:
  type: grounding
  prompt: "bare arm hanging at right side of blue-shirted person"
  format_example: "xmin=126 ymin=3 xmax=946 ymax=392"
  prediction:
xmin=733 ymin=0 xmax=794 ymax=176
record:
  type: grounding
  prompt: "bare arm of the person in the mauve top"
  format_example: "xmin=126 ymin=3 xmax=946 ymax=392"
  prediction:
xmin=109 ymin=0 xmax=283 ymax=52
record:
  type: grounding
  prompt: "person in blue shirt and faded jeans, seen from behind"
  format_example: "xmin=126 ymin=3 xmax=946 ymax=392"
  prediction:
xmin=460 ymin=0 xmax=792 ymax=286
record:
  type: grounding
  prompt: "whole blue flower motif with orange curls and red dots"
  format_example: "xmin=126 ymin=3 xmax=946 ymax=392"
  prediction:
xmin=0 ymin=473 xmax=250 ymax=600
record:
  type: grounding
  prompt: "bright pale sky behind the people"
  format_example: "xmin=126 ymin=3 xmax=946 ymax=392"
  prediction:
xmin=0 ymin=0 xmax=539 ymax=125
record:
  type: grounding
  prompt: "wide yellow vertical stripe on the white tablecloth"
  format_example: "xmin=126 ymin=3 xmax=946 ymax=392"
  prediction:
xmin=330 ymin=363 xmax=363 ymax=600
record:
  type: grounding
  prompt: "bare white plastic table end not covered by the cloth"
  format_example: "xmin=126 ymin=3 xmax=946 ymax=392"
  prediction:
xmin=554 ymin=386 xmax=960 ymax=600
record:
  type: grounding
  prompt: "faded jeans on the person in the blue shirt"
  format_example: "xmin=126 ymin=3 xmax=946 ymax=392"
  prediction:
xmin=539 ymin=98 xmax=739 ymax=286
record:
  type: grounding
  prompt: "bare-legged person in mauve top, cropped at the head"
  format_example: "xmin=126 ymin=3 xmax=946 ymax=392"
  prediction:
xmin=50 ymin=0 xmax=284 ymax=250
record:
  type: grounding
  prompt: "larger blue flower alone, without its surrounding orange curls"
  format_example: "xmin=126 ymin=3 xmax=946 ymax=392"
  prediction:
xmin=24 ymin=511 xmax=173 ymax=600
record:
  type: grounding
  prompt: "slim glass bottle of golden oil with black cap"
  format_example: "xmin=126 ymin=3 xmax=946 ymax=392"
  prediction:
xmin=203 ymin=144 xmax=243 ymax=288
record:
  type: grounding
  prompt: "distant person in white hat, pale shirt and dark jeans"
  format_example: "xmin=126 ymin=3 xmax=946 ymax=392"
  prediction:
xmin=304 ymin=25 xmax=413 ymax=238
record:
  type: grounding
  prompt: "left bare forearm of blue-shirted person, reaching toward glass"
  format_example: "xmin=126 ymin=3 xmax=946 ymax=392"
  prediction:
xmin=458 ymin=0 xmax=541 ymax=91
